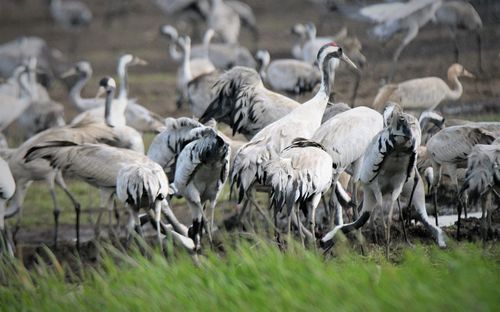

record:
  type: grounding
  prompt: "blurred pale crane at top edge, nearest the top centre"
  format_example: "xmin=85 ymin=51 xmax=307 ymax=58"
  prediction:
xmin=207 ymin=0 xmax=241 ymax=43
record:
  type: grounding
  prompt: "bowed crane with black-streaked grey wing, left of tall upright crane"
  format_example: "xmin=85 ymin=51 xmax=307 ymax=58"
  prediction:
xmin=172 ymin=127 xmax=231 ymax=249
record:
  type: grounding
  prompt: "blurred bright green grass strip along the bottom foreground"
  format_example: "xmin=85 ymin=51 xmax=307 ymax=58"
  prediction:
xmin=0 ymin=243 xmax=500 ymax=311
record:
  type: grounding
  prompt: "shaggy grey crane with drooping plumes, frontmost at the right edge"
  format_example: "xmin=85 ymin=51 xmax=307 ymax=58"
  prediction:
xmin=457 ymin=144 xmax=500 ymax=240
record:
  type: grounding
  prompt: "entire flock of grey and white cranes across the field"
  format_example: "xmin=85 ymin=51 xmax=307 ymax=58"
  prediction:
xmin=0 ymin=0 xmax=500 ymax=254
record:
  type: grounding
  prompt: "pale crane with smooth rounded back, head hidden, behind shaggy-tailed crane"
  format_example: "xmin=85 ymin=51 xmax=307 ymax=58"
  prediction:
xmin=312 ymin=106 xmax=384 ymax=224
